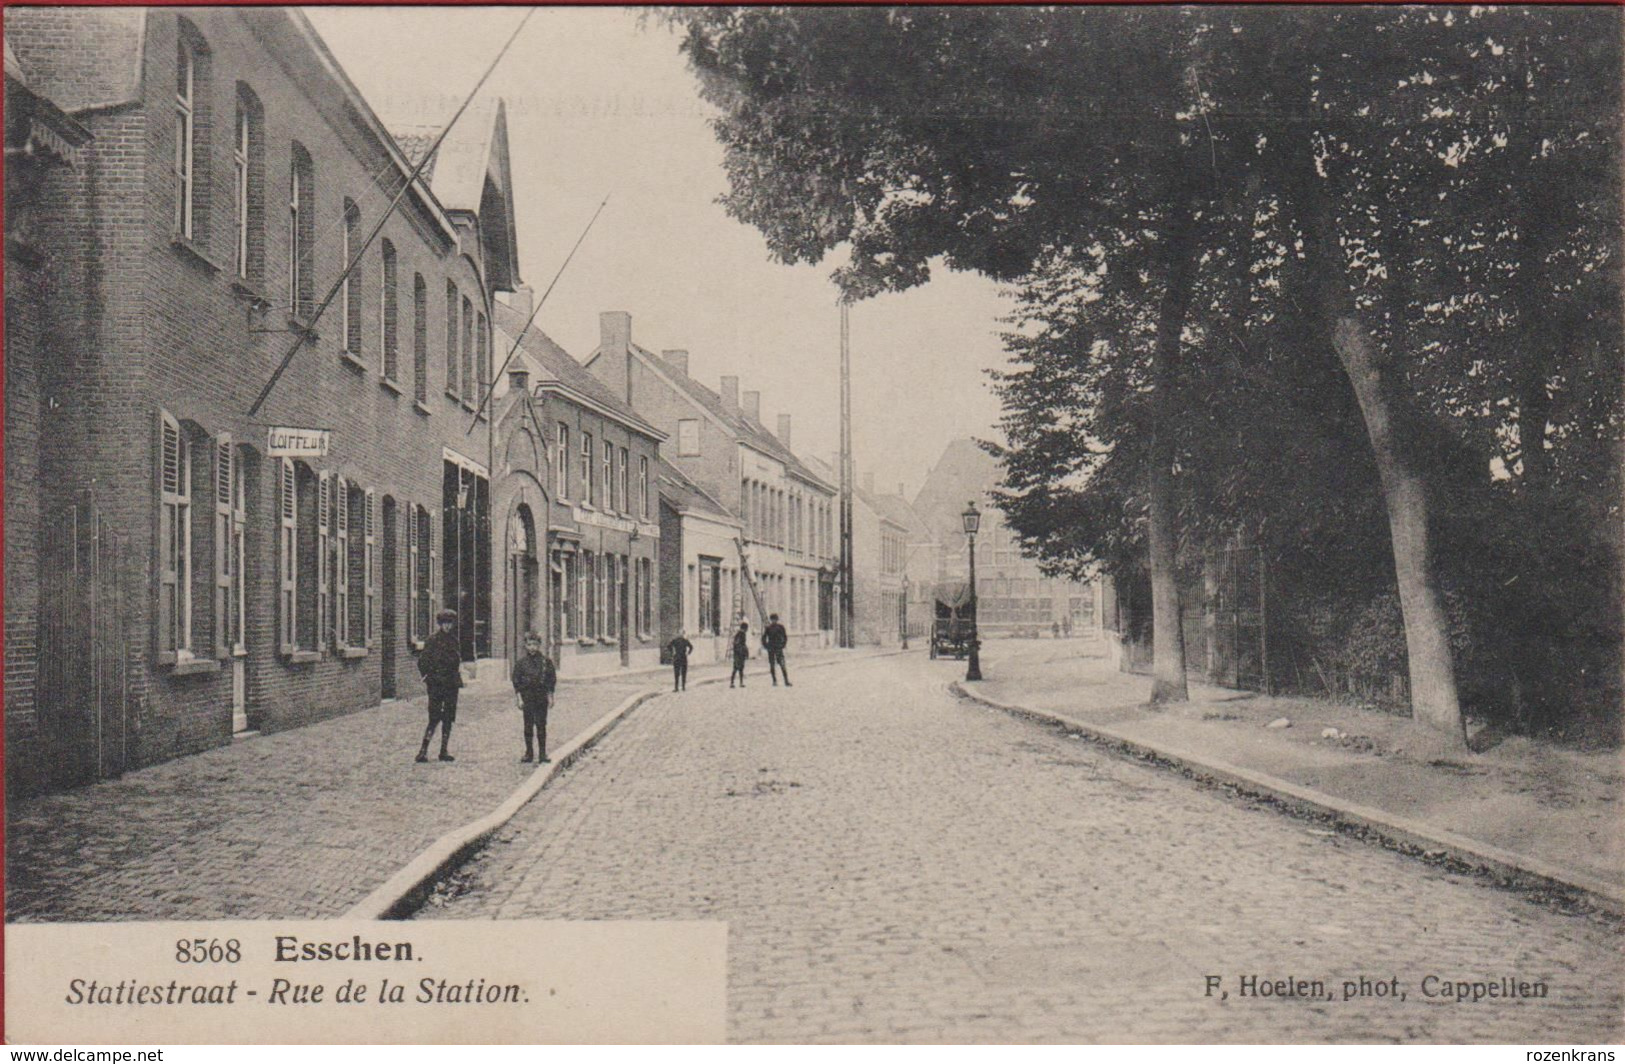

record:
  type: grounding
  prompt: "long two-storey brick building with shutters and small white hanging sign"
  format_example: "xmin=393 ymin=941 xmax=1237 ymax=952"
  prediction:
xmin=7 ymin=8 xmax=518 ymax=789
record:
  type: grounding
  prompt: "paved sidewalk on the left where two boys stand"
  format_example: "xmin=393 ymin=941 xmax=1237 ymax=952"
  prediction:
xmin=5 ymin=651 xmax=871 ymax=923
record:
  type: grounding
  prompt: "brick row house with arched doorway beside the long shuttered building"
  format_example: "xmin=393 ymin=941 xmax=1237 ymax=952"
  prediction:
xmin=496 ymin=295 xmax=666 ymax=676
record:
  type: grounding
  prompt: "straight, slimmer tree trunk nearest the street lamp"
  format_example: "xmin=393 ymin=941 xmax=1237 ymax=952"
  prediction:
xmin=1146 ymin=190 xmax=1196 ymax=702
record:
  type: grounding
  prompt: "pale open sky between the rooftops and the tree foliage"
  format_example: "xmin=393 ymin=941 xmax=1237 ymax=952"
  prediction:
xmin=306 ymin=6 xmax=1008 ymax=499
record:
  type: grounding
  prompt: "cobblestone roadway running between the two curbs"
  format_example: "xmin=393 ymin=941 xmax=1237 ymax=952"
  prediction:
xmin=423 ymin=655 xmax=1625 ymax=1043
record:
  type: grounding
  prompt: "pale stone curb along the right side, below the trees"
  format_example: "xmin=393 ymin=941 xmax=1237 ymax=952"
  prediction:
xmin=949 ymin=681 xmax=1625 ymax=916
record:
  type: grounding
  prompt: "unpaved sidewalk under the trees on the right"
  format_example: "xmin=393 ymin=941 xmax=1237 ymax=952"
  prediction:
xmin=959 ymin=640 xmax=1625 ymax=911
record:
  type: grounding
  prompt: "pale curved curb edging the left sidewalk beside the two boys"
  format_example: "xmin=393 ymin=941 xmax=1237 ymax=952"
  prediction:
xmin=343 ymin=650 xmax=907 ymax=919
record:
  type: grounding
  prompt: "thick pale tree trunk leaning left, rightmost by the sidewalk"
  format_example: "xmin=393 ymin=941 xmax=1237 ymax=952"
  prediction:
xmin=1333 ymin=314 xmax=1467 ymax=744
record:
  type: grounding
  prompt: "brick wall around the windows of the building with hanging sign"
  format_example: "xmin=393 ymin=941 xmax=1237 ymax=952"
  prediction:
xmin=7 ymin=8 xmax=533 ymax=789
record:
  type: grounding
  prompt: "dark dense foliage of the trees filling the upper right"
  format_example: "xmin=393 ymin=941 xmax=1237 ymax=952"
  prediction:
xmin=671 ymin=6 xmax=1622 ymax=740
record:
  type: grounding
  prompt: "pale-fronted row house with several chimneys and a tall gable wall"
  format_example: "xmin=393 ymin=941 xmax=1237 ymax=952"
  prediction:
xmin=587 ymin=312 xmax=839 ymax=648
